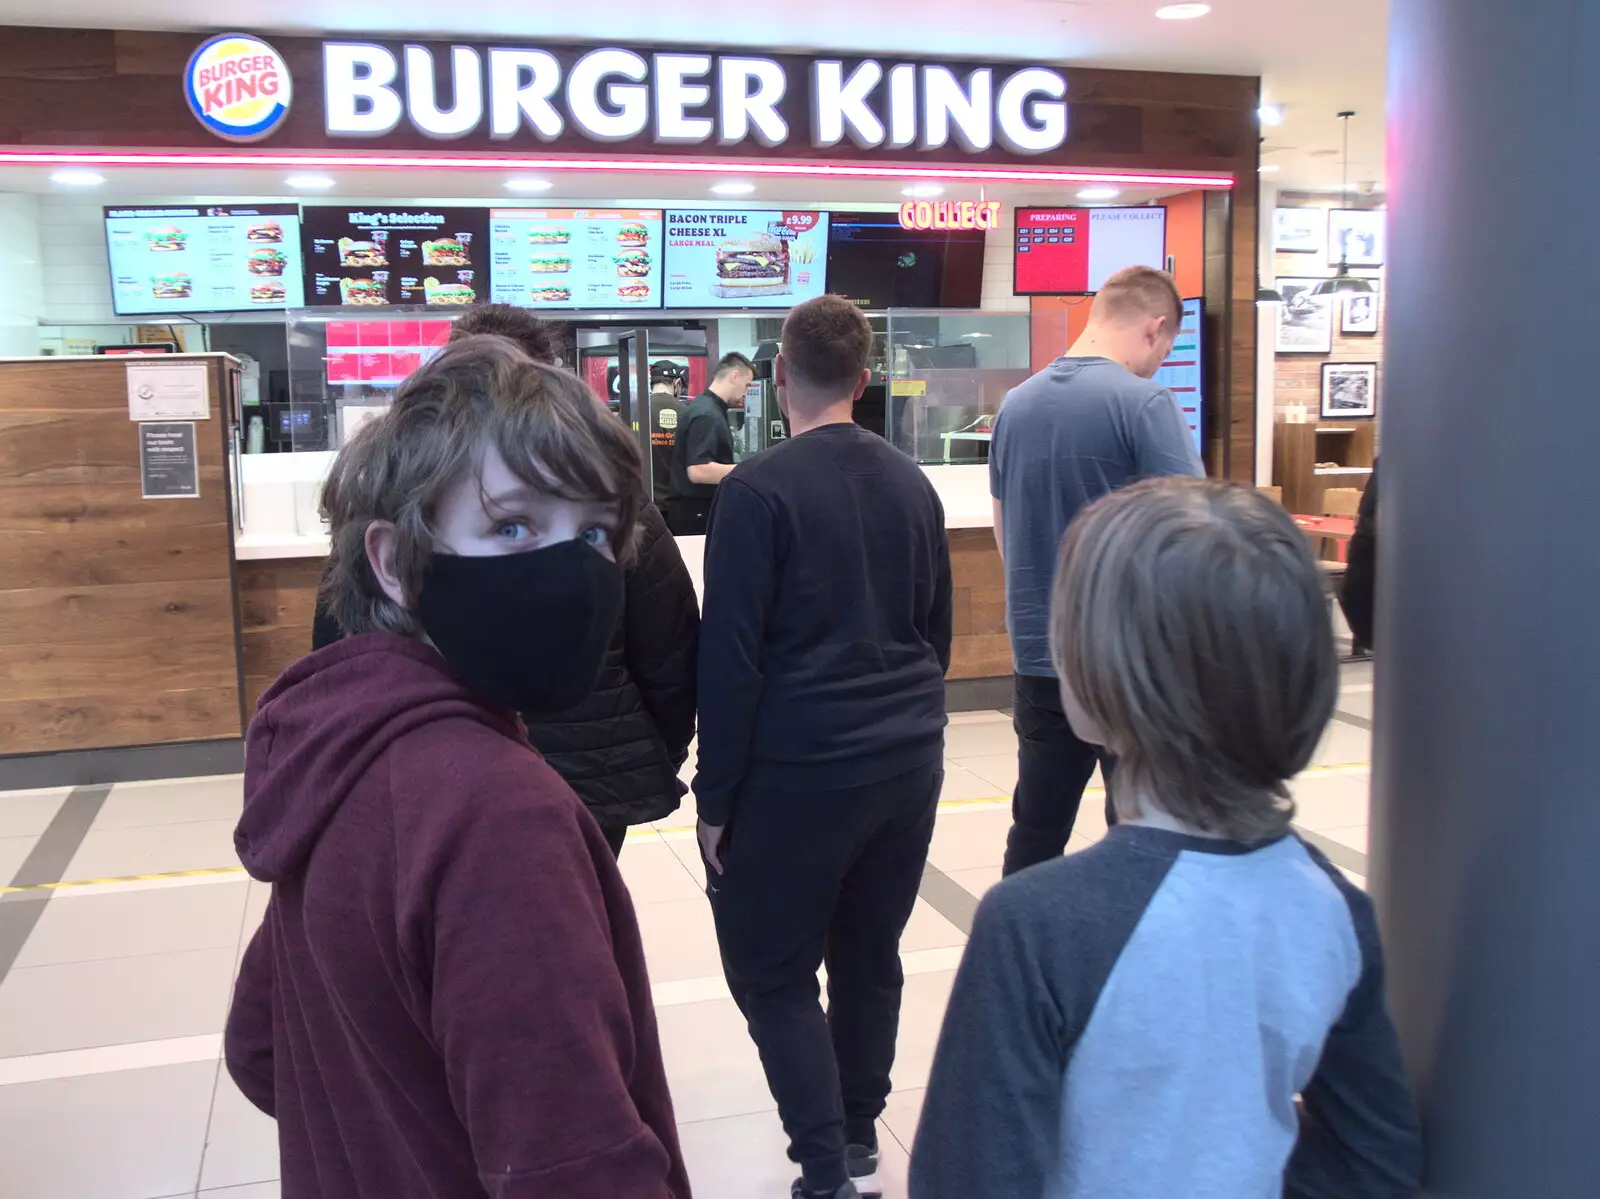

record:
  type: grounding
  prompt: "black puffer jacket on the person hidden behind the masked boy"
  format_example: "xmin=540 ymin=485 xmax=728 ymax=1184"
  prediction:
xmin=312 ymin=504 xmax=699 ymax=824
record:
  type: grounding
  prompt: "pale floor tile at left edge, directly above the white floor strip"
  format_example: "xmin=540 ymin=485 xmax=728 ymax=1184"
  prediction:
xmin=0 ymin=948 xmax=234 ymax=1057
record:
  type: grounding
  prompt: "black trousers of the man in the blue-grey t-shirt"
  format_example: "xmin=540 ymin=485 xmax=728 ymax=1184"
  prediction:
xmin=1005 ymin=674 xmax=1117 ymax=874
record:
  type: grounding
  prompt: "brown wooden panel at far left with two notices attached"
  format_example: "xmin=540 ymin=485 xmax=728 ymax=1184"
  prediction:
xmin=0 ymin=357 xmax=242 ymax=754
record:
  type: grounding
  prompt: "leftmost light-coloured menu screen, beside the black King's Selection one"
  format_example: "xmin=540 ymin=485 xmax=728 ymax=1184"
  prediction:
xmin=106 ymin=203 xmax=302 ymax=317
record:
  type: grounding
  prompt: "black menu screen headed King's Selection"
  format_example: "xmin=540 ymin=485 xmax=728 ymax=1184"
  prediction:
xmin=302 ymin=207 xmax=490 ymax=307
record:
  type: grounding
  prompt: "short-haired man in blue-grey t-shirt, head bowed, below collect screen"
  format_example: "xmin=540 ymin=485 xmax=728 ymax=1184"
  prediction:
xmin=989 ymin=266 xmax=1205 ymax=874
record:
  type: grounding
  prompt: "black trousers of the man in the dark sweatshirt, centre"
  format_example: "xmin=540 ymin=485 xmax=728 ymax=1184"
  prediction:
xmin=706 ymin=764 xmax=944 ymax=1194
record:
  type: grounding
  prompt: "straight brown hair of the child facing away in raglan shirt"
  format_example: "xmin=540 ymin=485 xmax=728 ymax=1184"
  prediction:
xmin=1050 ymin=479 xmax=1339 ymax=844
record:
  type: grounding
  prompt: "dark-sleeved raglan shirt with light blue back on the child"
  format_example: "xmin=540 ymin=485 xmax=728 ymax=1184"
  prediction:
xmin=910 ymin=824 xmax=1422 ymax=1199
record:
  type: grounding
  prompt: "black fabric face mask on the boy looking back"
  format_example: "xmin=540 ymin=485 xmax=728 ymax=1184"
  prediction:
xmin=416 ymin=541 xmax=622 ymax=716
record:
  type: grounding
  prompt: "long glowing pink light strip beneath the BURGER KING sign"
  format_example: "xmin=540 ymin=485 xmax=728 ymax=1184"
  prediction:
xmin=0 ymin=150 xmax=1235 ymax=187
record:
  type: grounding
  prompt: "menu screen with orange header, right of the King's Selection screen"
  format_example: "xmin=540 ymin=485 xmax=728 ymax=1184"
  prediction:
xmin=490 ymin=208 xmax=661 ymax=307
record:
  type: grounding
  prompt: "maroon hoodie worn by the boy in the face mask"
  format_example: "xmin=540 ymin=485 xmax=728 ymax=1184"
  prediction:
xmin=227 ymin=636 xmax=690 ymax=1199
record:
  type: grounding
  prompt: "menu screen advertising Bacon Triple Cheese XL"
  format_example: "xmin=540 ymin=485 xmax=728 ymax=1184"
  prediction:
xmin=662 ymin=208 xmax=827 ymax=307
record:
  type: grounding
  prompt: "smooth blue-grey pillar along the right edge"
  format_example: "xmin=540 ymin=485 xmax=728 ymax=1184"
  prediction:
xmin=1373 ymin=0 xmax=1600 ymax=1199
